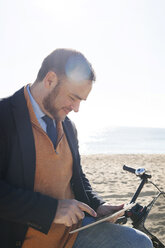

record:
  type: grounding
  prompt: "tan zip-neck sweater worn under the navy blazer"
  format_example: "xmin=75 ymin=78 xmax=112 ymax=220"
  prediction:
xmin=22 ymin=88 xmax=80 ymax=248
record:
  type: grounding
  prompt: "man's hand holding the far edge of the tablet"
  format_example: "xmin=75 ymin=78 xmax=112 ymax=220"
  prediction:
xmin=97 ymin=203 xmax=124 ymax=223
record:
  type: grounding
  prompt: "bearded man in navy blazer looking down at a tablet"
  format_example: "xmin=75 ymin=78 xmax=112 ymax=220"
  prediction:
xmin=0 ymin=49 xmax=152 ymax=248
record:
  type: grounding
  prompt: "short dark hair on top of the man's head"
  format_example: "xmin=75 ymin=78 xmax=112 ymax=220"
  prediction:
xmin=36 ymin=48 xmax=96 ymax=82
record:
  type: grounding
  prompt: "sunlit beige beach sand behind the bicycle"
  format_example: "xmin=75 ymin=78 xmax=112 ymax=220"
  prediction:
xmin=81 ymin=154 xmax=165 ymax=243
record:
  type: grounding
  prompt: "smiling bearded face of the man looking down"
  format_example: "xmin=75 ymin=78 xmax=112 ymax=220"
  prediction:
xmin=43 ymin=80 xmax=92 ymax=121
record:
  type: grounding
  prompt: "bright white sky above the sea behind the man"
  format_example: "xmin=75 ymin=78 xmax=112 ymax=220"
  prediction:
xmin=0 ymin=0 xmax=165 ymax=137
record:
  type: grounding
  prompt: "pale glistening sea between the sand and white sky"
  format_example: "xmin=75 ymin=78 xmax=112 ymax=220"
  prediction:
xmin=79 ymin=127 xmax=165 ymax=154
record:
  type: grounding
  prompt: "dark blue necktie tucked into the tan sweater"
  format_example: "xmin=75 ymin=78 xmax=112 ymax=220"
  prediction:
xmin=42 ymin=115 xmax=57 ymax=148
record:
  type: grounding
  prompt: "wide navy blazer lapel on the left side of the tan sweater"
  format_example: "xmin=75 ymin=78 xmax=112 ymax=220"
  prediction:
xmin=11 ymin=88 xmax=35 ymax=190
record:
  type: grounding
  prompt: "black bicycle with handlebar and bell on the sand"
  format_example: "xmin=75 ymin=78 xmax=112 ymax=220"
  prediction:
xmin=117 ymin=165 xmax=165 ymax=248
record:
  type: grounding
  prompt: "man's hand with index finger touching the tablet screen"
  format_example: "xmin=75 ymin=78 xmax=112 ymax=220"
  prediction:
xmin=54 ymin=199 xmax=97 ymax=226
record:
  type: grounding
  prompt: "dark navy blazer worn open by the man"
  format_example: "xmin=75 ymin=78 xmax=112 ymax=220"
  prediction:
xmin=0 ymin=88 xmax=103 ymax=248
